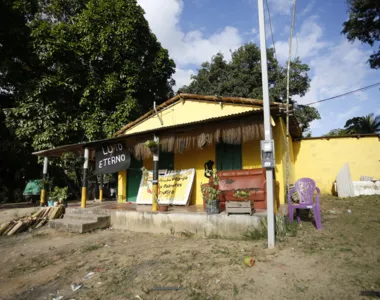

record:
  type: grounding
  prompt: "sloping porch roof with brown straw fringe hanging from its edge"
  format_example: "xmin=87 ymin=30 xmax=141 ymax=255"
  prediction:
xmin=33 ymin=108 xmax=301 ymax=159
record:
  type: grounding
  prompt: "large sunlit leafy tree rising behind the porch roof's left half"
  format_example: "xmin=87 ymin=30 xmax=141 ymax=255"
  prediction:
xmin=8 ymin=0 xmax=175 ymax=149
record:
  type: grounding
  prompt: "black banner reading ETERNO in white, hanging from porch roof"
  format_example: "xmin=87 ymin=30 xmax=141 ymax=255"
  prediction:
xmin=95 ymin=143 xmax=131 ymax=174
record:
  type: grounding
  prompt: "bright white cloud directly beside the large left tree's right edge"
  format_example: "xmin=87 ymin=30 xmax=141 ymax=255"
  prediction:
xmin=138 ymin=0 xmax=243 ymax=68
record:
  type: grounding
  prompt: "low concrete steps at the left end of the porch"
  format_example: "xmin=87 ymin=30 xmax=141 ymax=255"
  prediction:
xmin=49 ymin=214 xmax=111 ymax=233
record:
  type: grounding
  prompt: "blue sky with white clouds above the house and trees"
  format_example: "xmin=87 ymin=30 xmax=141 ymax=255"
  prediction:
xmin=138 ymin=0 xmax=380 ymax=136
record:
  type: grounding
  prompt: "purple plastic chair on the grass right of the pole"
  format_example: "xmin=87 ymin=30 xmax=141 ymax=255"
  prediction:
xmin=288 ymin=178 xmax=322 ymax=230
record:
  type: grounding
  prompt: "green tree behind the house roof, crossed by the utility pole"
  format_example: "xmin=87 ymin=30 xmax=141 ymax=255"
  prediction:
xmin=180 ymin=43 xmax=320 ymax=132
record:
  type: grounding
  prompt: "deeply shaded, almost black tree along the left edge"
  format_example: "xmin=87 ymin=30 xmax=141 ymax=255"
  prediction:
xmin=0 ymin=0 xmax=41 ymax=202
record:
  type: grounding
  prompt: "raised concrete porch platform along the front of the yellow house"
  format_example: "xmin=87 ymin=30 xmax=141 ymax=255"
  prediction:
xmin=66 ymin=201 xmax=267 ymax=238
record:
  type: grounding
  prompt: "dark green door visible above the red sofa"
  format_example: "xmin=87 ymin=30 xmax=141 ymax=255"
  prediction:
xmin=216 ymin=143 xmax=242 ymax=171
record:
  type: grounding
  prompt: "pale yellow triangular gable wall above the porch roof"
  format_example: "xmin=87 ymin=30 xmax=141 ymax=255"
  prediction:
xmin=126 ymin=100 xmax=260 ymax=134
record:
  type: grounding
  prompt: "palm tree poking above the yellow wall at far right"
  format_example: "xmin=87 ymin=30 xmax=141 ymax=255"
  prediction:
xmin=344 ymin=113 xmax=380 ymax=134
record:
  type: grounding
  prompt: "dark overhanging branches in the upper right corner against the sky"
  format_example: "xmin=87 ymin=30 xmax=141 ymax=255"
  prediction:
xmin=342 ymin=0 xmax=380 ymax=69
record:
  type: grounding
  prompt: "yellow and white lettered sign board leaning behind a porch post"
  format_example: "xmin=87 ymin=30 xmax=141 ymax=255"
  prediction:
xmin=136 ymin=169 xmax=195 ymax=205
